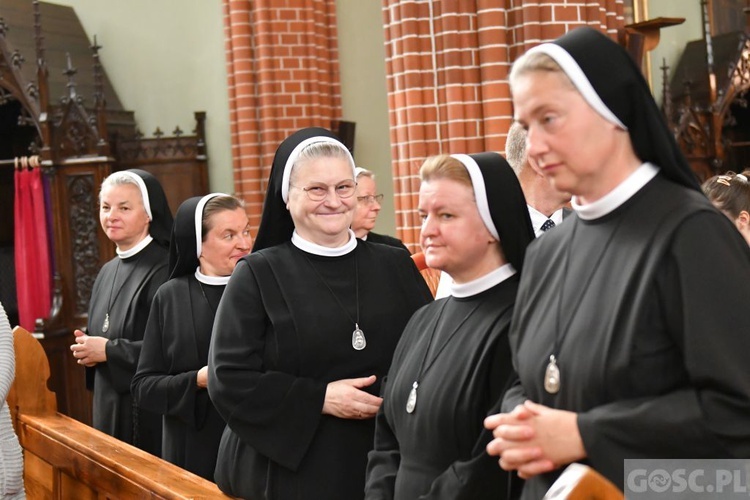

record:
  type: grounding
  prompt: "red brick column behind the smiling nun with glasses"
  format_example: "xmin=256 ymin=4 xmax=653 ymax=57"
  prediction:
xmin=223 ymin=0 xmax=341 ymax=229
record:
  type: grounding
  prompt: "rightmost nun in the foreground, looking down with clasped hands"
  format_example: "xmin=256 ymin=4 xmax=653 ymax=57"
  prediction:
xmin=486 ymin=28 xmax=750 ymax=499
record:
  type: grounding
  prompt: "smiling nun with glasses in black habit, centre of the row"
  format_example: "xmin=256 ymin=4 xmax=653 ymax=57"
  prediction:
xmin=208 ymin=128 xmax=432 ymax=500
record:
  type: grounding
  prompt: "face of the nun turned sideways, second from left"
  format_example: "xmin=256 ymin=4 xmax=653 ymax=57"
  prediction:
xmin=199 ymin=208 xmax=253 ymax=276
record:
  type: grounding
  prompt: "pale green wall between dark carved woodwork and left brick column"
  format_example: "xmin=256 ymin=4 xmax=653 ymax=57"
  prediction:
xmin=42 ymin=0 xmax=234 ymax=192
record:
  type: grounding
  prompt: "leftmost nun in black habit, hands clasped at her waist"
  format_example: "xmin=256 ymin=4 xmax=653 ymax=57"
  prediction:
xmin=70 ymin=169 xmax=172 ymax=456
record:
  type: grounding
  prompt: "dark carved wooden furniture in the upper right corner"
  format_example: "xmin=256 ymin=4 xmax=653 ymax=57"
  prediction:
xmin=662 ymin=0 xmax=750 ymax=180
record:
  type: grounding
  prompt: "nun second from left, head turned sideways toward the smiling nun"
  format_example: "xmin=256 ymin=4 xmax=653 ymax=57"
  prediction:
xmin=132 ymin=193 xmax=251 ymax=481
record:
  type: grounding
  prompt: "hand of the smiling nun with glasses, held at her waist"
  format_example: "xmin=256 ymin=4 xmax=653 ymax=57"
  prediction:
xmin=323 ymin=375 xmax=383 ymax=420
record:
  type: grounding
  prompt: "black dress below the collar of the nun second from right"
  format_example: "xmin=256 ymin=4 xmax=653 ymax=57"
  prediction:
xmin=366 ymin=275 xmax=518 ymax=500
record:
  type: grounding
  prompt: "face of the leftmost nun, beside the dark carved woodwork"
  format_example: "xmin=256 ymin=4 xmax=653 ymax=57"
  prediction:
xmin=99 ymin=184 xmax=149 ymax=251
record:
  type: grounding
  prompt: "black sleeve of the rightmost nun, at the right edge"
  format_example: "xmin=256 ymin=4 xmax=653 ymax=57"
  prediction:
xmin=578 ymin=212 xmax=750 ymax=475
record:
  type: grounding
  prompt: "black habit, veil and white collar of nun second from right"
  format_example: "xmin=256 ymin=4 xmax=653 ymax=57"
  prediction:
xmin=366 ymin=153 xmax=534 ymax=500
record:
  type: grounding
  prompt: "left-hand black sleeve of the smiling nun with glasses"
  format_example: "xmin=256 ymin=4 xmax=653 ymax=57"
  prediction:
xmin=208 ymin=260 xmax=327 ymax=470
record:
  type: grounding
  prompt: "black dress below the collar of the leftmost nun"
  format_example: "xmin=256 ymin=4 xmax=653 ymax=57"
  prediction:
xmin=86 ymin=241 xmax=167 ymax=456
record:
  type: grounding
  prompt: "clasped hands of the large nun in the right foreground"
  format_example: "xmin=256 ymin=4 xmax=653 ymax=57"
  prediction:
xmin=484 ymin=401 xmax=586 ymax=479
